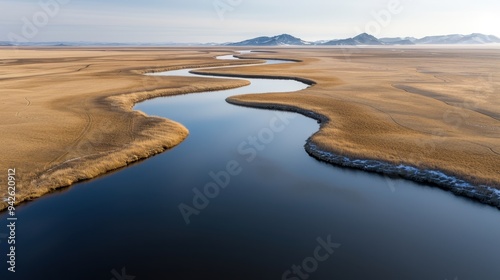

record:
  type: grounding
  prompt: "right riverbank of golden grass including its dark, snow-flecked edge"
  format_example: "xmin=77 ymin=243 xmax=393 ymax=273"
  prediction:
xmin=217 ymin=49 xmax=500 ymax=208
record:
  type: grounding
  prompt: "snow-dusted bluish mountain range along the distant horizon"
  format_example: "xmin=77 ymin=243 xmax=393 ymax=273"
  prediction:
xmin=225 ymin=33 xmax=500 ymax=46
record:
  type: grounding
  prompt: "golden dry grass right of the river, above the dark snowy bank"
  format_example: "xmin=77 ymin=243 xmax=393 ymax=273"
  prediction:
xmin=220 ymin=48 xmax=500 ymax=188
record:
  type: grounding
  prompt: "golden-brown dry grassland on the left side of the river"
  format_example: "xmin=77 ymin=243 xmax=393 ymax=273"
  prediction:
xmin=0 ymin=48 xmax=247 ymax=209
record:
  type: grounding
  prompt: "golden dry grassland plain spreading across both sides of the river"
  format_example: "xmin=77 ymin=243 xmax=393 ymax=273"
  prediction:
xmin=0 ymin=48 xmax=500 ymax=208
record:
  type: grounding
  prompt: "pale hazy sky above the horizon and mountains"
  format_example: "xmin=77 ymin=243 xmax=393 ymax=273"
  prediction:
xmin=0 ymin=0 xmax=500 ymax=43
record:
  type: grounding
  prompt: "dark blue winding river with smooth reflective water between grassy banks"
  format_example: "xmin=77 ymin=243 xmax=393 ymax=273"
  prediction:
xmin=0 ymin=53 xmax=500 ymax=280
